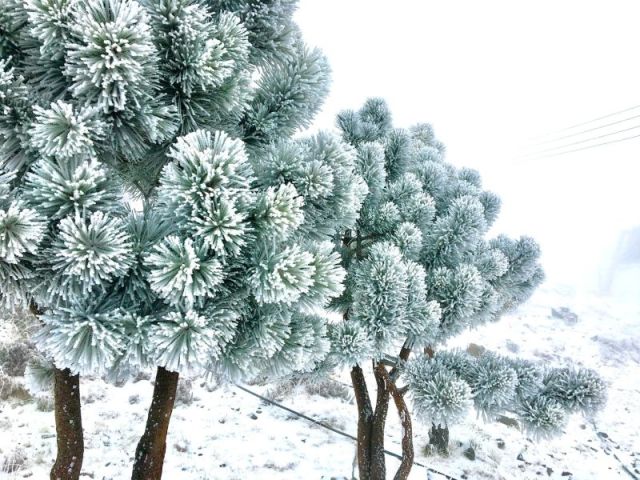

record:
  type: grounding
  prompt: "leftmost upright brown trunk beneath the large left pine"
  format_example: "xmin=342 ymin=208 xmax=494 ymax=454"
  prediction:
xmin=50 ymin=367 xmax=84 ymax=480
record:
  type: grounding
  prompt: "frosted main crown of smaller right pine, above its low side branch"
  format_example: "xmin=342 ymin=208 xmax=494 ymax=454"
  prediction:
xmin=332 ymin=99 xmax=543 ymax=364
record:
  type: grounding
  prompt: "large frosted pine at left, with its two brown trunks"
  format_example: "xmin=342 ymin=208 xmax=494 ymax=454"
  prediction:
xmin=0 ymin=0 xmax=367 ymax=479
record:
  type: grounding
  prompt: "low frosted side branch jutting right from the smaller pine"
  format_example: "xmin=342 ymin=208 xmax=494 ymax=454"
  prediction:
xmin=404 ymin=351 xmax=606 ymax=437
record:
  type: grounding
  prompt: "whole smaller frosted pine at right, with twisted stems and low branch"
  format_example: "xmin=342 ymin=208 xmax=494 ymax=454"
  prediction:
xmin=325 ymin=99 xmax=604 ymax=480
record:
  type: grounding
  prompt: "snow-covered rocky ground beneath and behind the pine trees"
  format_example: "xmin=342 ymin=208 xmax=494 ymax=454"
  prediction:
xmin=0 ymin=286 xmax=640 ymax=480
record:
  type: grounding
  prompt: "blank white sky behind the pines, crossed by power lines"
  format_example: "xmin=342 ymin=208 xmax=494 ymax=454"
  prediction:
xmin=297 ymin=0 xmax=640 ymax=292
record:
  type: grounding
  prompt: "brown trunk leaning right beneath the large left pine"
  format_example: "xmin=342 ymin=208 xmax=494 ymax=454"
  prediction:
xmin=131 ymin=367 xmax=179 ymax=480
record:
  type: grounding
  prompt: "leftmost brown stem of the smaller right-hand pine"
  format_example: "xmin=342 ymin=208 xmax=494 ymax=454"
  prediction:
xmin=351 ymin=365 xmax=373 ymax=480
